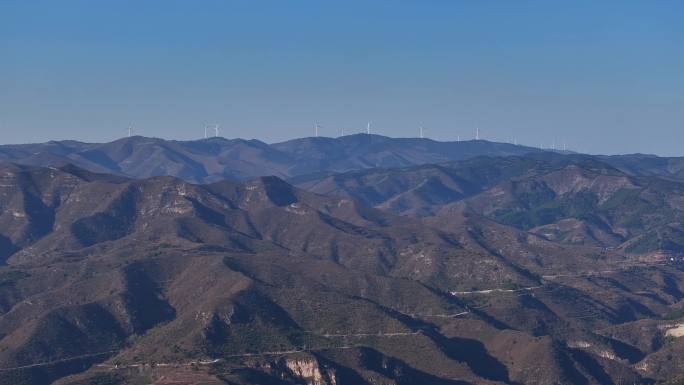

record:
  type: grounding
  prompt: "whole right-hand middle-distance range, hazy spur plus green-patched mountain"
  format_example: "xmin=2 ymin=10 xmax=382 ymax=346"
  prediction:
xmin=290 ymin=154 xmax=684 ymax=254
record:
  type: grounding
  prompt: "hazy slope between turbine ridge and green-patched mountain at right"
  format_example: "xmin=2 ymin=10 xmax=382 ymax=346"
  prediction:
xmin=289 ymin=156 xmax=552 ymax=216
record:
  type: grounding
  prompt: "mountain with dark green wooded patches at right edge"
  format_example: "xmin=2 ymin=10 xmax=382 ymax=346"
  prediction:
xmin=445 ymin=162 xmax=684 ymax=254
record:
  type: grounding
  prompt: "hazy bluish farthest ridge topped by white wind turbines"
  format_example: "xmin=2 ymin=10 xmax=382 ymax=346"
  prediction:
xmin=0 ymin=134 xmax=540 ymax=183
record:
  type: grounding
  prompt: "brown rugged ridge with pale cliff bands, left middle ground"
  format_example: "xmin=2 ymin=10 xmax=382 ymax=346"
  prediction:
xmin=0 ymin=165 xmax=536 ymax=284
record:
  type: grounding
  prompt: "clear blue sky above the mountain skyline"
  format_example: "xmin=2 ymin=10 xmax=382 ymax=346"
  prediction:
xmin=0 ymin=0 xmax=684 ymax=155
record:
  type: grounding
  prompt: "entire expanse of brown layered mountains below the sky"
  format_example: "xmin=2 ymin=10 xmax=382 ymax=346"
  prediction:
xmin=0 ymin=135 xmax=684 ymax=385
